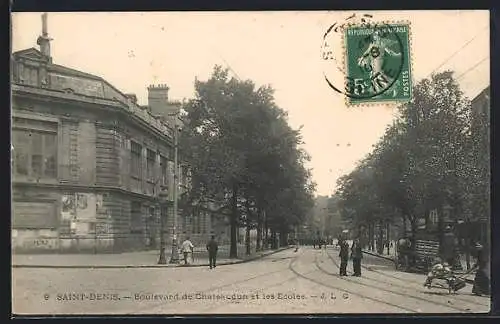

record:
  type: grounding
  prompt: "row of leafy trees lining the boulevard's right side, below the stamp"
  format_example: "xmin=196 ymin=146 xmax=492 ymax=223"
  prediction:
xmin=338 ymin=71 xmax=489 ymax=270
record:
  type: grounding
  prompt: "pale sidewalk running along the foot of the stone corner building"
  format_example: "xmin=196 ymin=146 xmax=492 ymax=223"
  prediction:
xmin=12 ymin=247 xmax=291 ymax=268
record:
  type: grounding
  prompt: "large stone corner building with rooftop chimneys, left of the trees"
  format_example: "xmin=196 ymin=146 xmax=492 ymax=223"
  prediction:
xmin=11 ymin=14 xmax=225 ymax=252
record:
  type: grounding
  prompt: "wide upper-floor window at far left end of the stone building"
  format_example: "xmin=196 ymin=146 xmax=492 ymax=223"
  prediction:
xmin=12 ymin=118 xmax=58 ymax=179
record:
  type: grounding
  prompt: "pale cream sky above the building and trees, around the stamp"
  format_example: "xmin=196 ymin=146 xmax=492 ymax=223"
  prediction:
xmin=12 ymin=10 xmax=490 ymax=195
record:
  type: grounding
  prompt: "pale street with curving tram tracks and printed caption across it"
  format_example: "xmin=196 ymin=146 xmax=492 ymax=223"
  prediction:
xmin=13 ymin=247 xmax=490 ymax=315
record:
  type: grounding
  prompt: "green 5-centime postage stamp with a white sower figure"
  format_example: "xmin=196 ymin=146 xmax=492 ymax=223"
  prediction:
xmin=344 ymin=23 xmax=412 ymax=105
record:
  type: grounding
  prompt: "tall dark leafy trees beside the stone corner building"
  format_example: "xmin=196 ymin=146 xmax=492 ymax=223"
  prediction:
xmin=179 ymin=66 xmax=314 ymax=258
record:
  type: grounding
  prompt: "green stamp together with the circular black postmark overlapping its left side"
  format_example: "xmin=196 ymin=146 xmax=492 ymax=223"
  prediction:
xmin=322 ymin=14 xmax=412 ymax=105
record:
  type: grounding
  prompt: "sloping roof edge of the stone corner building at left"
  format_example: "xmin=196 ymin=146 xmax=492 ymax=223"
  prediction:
xmin=13 ymin=48 xmax=176 ymax=136
